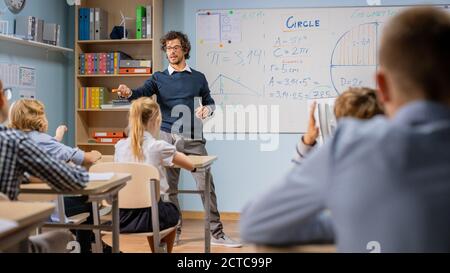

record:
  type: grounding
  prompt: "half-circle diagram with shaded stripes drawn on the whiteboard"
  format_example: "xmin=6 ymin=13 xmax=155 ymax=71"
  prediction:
xmin=330 ymin=22 xmax=380 ymax=94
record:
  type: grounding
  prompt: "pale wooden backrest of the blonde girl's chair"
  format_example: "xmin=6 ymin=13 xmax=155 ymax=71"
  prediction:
xmin=89 ymin=162 xmax=160 ymax=209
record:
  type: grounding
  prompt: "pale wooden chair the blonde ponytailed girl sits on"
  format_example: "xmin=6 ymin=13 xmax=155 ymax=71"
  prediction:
xmin=89 ymin=162 xmax=176 ymax=252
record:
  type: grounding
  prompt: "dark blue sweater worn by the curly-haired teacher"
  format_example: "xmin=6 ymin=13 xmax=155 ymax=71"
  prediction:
xmin=129 ymin=68 xmax=214 ymax=138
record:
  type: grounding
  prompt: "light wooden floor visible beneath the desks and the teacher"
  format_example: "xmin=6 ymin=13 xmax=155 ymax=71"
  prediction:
xmin=103 ymin=219 xmax=335 ymax=253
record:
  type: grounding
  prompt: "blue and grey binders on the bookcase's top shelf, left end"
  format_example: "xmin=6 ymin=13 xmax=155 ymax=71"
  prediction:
xmin=78 ymin=8 xmax=108 ymax=41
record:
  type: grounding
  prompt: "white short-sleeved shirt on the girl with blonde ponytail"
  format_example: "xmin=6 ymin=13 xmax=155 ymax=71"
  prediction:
xmin=114 ymin=132 xmax=176 ymax=194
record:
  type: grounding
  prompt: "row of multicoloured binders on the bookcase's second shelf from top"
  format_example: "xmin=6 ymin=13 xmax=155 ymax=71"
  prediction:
xmin=78 ymin=52 xmax=132 ymax=75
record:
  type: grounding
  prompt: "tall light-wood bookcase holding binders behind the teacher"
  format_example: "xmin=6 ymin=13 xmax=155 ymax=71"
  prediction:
xmin=74 ymin=0 xmax=163 ymax=155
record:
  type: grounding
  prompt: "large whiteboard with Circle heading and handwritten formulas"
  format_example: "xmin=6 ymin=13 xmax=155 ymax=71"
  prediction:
xmin=196 ymin=6 xmax=448 ymax=133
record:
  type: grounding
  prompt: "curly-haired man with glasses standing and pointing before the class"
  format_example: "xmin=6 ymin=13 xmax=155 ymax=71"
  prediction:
xmin=118 ymin=31 xmax=242 ymax=247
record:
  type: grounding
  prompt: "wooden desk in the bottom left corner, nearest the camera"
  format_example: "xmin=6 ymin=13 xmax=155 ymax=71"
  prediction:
xmin=0 ymin=201 xmax=55 ymax=252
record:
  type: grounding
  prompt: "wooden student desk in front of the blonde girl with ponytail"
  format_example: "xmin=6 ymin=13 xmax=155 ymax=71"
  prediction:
xmin=175 ymin=155 xmax=217 ymax=253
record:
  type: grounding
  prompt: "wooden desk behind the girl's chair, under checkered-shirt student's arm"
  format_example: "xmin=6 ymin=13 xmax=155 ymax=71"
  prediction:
xmin=20 ymin=173 xmax=131 ymax=253
